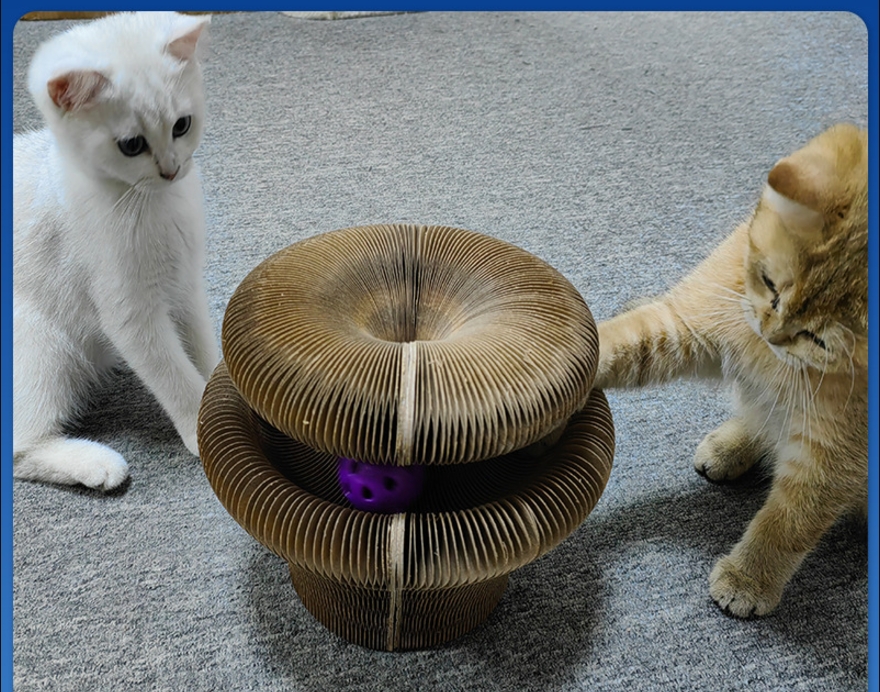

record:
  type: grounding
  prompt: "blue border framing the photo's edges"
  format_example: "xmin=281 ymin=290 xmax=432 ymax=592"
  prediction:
xmin=0 ymin=5 xmax=880 ymax=691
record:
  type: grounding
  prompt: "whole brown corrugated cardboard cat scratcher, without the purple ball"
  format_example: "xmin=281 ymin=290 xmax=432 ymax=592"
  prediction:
xmin=199 ymin=225 xmax=614 ymax=650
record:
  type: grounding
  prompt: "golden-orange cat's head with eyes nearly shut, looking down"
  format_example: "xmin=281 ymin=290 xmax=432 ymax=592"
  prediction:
xmin=745 ymin=124 xmax=868 ymax=372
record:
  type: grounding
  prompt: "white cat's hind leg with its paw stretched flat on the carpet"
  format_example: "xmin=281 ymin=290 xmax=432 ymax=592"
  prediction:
xmin=12 ymin=300 xmax=128 ymax=490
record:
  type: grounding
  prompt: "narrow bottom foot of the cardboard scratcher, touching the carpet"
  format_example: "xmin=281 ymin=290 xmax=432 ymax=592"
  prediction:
xmin=290 ymin=565 xmax=508 ymax=651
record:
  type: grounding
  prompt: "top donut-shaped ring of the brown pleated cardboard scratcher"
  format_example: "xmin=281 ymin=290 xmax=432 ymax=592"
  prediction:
xmin=223 ymin=225 xmax=598 ymax=465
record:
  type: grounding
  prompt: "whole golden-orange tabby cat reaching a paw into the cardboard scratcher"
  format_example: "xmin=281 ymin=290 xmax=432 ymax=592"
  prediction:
xmin=595 ymin=124 xmax=868 ymax=617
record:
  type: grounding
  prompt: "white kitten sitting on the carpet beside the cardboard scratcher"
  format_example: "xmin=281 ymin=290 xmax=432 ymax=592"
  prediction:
xmin=13 ymin=12 xmax=219 ymax=490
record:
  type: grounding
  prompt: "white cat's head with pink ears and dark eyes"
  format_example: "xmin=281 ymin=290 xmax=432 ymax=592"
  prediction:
xmin=28 ymin=12 xmax=210 ymax=186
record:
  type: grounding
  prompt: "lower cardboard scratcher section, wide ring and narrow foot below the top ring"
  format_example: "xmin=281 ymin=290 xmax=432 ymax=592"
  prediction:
xmin=199 ymin=363 xmax=614 ymax=651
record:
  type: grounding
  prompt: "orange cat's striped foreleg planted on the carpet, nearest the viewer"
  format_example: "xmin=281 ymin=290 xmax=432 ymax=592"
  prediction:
xmin=709 ymin=448 xmax=851 ymax=617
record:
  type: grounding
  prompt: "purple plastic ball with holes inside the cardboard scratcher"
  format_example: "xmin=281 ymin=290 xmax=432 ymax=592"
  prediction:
xmin=338 ymin=457 xmax=425 ymax=514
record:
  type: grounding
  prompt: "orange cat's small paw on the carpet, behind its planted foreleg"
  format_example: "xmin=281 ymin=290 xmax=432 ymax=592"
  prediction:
xmin=694 ymin=418 xmax=764 ymax=482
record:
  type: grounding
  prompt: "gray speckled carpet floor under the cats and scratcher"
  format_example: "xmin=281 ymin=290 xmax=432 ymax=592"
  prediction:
xmin=13 ymin=13 xmax=868 ymax=692
